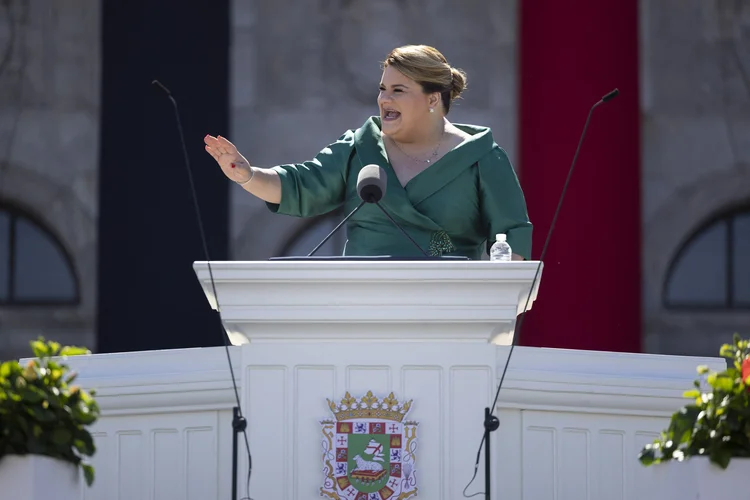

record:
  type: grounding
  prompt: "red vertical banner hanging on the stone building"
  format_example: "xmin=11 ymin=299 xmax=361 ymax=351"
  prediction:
xmin=518 ymin=0 xmax=641 ymax=352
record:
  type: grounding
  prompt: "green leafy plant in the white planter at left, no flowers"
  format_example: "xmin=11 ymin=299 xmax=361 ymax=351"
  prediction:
xmin=0 ymin=338 xmax=99 ymax=486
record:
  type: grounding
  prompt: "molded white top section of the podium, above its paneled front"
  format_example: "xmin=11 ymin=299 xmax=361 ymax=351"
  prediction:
xmin=194 ymin=261 xmax=541 ymax=345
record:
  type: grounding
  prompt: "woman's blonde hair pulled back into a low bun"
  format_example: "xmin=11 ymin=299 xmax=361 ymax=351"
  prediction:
xmin=383 ymin=45 xmax=467 ymax=114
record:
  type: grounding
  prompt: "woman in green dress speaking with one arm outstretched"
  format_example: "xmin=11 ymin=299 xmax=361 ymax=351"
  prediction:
xmin=204 ymin=45 xmax=532 ymax=260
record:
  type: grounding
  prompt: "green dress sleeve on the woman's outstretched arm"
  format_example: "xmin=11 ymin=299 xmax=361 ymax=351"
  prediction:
xmin=266 ymin=130 xmax=354 ymax=217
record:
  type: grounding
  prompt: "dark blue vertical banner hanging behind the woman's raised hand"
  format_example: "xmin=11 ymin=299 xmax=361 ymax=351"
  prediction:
xmin=96 ymin=0 xmax=230 ymax=352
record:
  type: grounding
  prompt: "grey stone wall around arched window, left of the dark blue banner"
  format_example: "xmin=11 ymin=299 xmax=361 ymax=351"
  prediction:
xmin=0 ymin=0 xmax=100 ymax=359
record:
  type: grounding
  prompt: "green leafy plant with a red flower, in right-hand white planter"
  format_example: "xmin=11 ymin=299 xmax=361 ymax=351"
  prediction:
xmin=638 ymin=335 xmax=750 ymax=469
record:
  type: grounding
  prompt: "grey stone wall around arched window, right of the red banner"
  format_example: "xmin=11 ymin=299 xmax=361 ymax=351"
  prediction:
xmin=641 ymin=0 xmax=750 ymax=355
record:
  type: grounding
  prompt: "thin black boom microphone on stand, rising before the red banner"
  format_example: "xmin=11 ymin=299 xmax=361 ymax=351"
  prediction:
xmin=463 ymin=89 xmax=620 ymax=500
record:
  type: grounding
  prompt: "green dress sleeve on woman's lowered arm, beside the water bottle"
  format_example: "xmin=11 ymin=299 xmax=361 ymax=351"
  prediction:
xmin=479 ymin=146 xmax=532 ymax=260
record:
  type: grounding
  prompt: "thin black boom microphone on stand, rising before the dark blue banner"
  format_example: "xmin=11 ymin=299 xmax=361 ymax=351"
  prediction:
xmin=151 ymin=80 xmax=253 ymax=500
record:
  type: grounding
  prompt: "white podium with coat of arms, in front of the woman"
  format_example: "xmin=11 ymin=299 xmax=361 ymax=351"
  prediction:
xmin=194 ymin=261 xmax=541 ymax=500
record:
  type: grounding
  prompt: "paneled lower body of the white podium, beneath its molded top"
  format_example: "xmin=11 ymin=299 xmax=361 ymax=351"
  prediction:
xmin=242 ymin=342 xmax=496 ymax=499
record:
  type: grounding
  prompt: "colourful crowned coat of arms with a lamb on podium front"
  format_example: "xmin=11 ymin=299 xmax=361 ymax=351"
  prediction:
xmin=320 ymin=391 xmax=418 ymax=500
